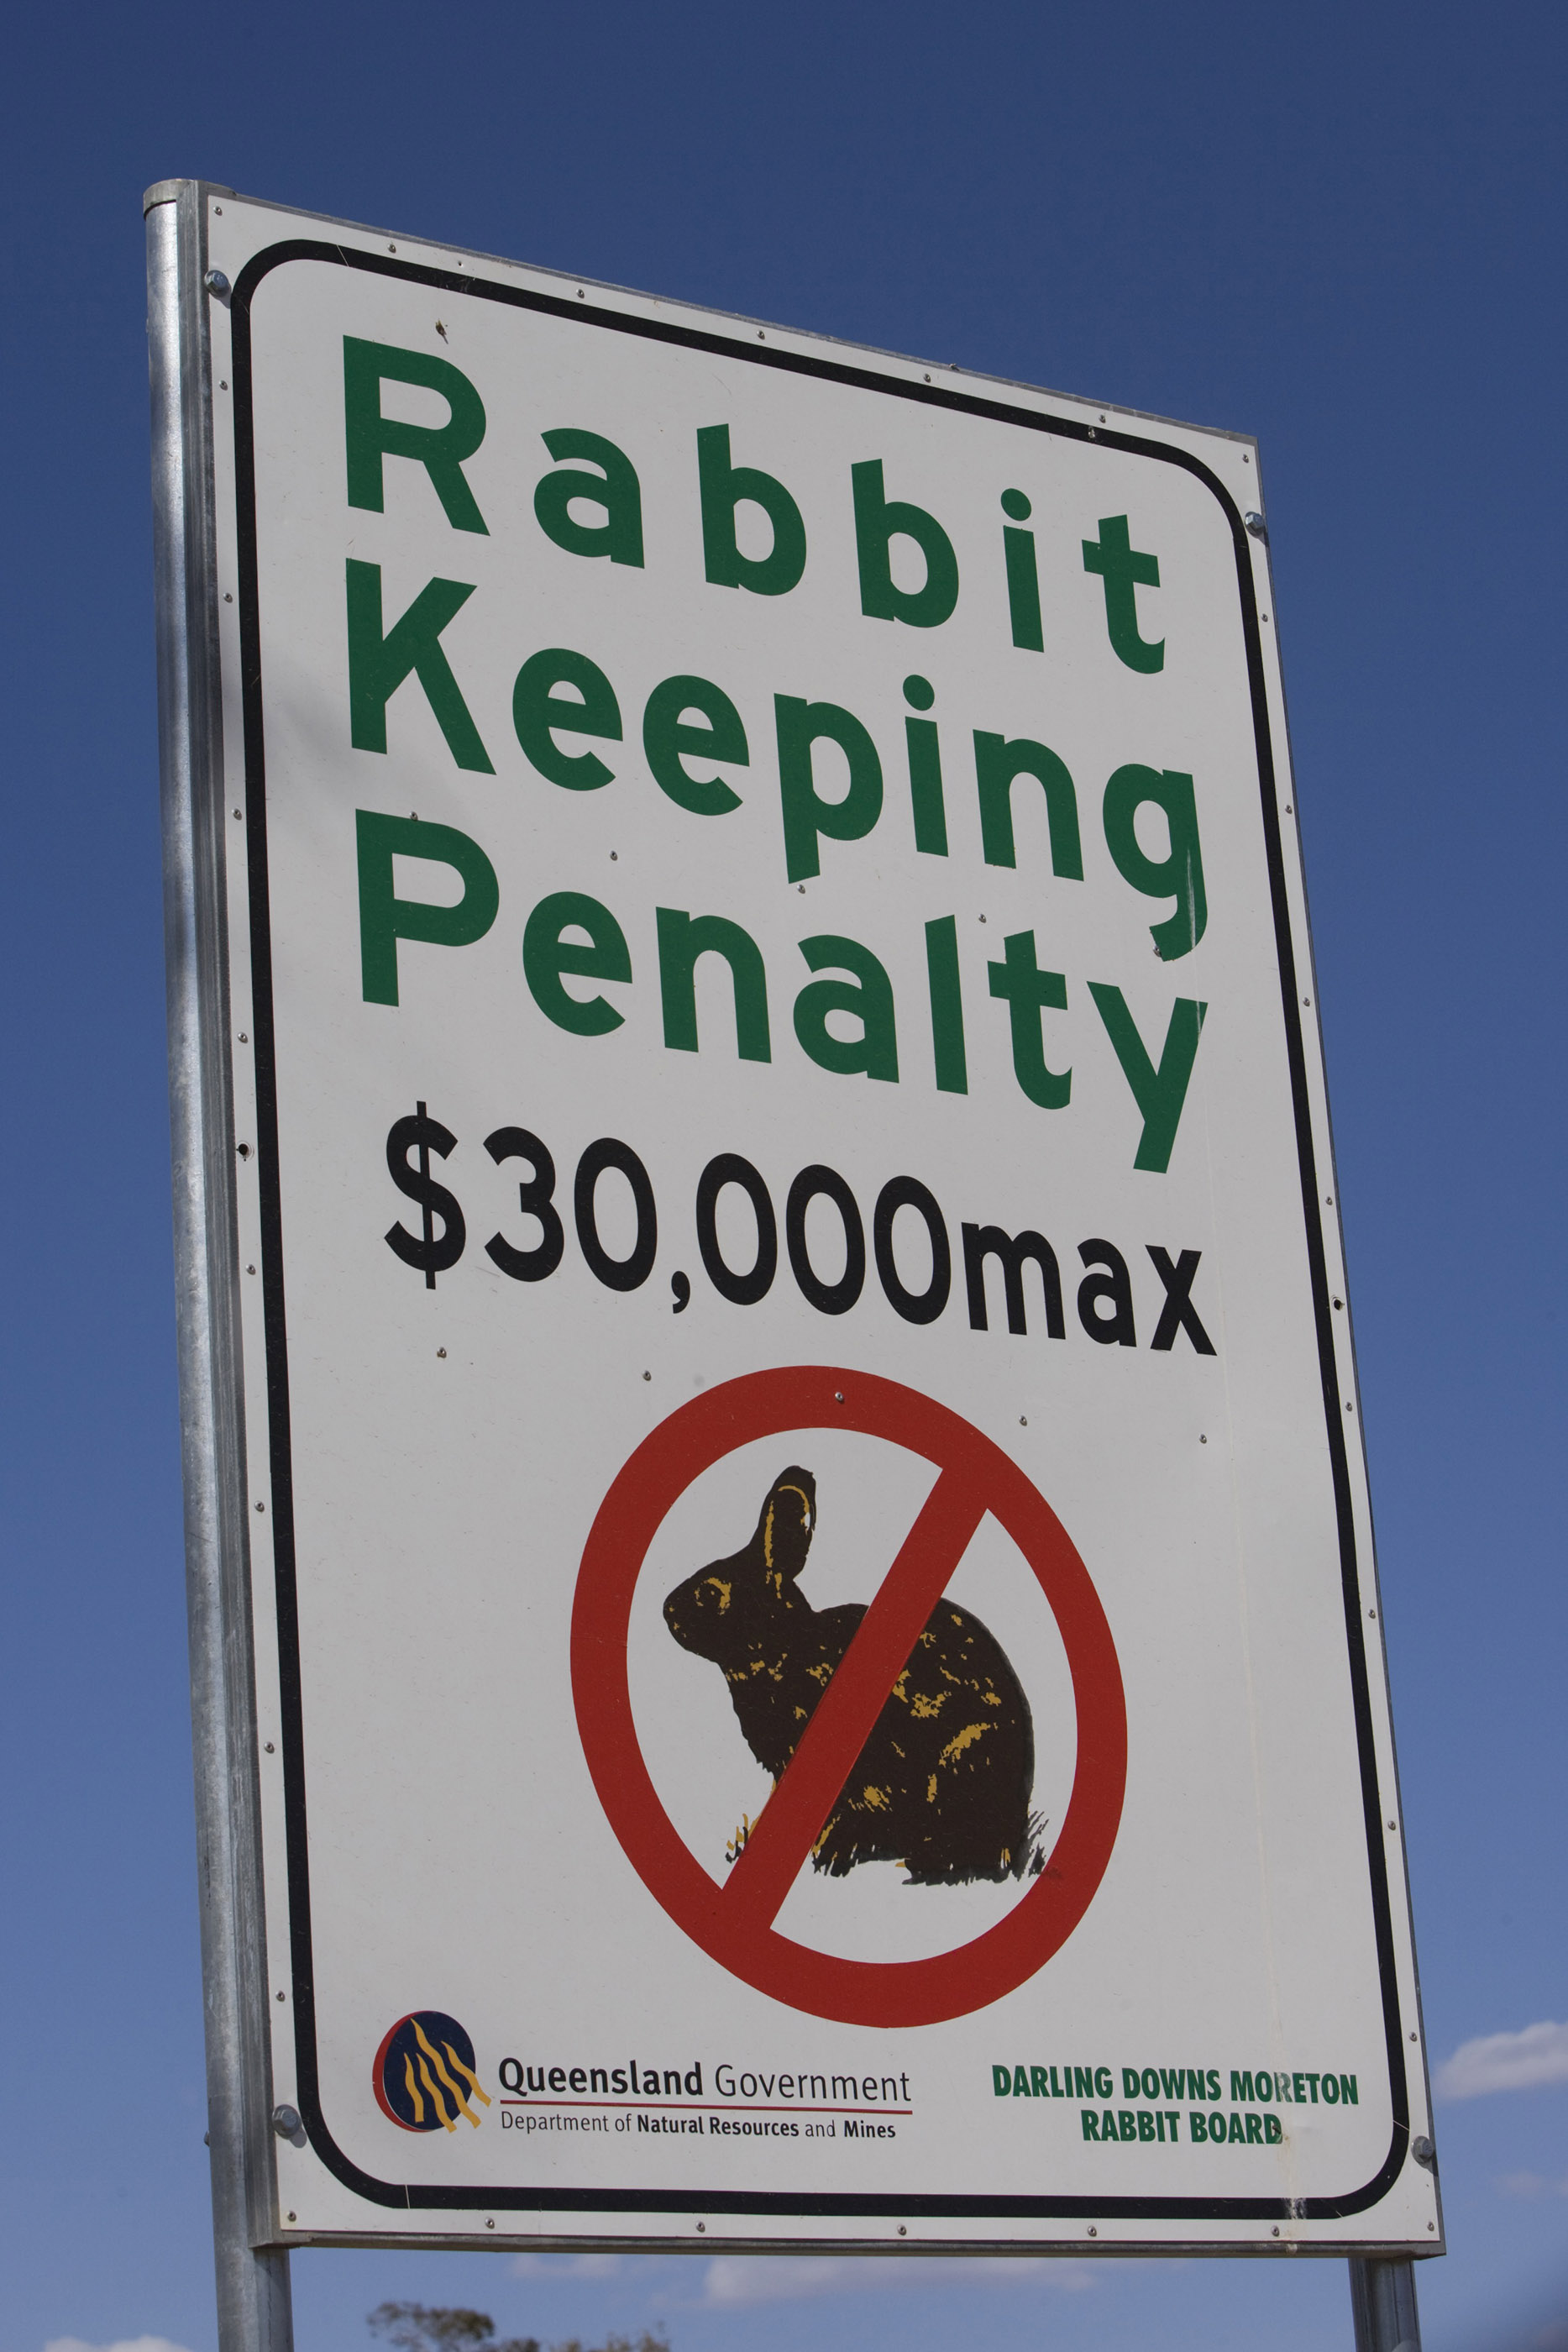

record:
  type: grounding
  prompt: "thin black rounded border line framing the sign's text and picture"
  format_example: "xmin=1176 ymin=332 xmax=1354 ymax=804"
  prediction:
xmin=230 ymin=238 xmax=1410 ymax=2220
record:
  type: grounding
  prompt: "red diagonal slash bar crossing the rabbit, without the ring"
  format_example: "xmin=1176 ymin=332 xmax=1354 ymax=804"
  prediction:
xmin=724 ymin=1470 xmax=985 ymax=1929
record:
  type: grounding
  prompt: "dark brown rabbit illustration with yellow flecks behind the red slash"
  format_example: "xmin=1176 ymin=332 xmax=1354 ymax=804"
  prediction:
xmin=665 ymin=1467 xmax=1039 ymax=1887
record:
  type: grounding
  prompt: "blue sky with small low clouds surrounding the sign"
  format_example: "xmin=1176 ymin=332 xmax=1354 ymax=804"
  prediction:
xmin=0 ymin=0 xmax=1568 ymax=2352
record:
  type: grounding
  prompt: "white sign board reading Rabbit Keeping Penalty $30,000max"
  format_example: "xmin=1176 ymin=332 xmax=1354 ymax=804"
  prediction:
xmin=171 ymin=193 xmax=1441 ymax=2253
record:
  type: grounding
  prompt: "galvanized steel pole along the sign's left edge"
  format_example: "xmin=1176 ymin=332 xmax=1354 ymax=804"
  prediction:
xmin=144 ymin=181 xmax=294 ymax=2352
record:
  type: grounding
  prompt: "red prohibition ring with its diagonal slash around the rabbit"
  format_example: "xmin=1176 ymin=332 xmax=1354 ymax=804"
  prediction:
xmin=571 ymin=1364 xmax=1126 ymax=2025
